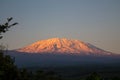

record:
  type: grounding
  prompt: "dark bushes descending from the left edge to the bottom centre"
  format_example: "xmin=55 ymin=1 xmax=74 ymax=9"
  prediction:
xmin=0 ymin=51 xmax=61 ymax=80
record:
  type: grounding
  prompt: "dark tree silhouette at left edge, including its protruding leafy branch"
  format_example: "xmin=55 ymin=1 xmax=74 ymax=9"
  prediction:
xmin=0 ymin=17 xmax=19 ymax=80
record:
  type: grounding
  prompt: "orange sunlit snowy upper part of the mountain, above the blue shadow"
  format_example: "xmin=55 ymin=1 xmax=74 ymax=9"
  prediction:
xmin=16 ymin=38 xmax=113 ymax=55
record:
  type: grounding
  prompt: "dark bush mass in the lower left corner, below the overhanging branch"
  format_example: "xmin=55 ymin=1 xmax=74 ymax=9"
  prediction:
xmin=0 ymin=52 xmax=19 ymax=80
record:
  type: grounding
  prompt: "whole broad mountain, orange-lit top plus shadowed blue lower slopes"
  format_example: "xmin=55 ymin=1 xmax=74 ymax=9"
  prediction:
xmin=6 ymin=38 xmax=120 ymax=67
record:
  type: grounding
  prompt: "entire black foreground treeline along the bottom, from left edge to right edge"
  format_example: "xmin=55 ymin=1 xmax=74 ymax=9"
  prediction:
xmin=0 ymin=50 xmax=120 ymax=80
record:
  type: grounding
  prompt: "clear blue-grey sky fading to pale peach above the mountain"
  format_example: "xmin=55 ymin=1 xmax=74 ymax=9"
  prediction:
xmin=0 ymin=0 xmax=120 ymax=53
